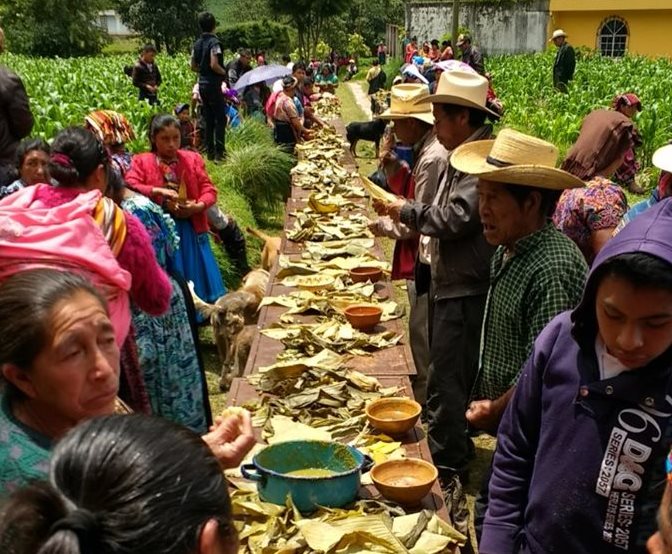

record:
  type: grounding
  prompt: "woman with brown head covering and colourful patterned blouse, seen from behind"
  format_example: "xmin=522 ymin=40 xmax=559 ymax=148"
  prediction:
xmin=553 ymin=110 xmax=633 ymax=265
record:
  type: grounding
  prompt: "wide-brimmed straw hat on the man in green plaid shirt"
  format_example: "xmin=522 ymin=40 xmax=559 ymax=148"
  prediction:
xmin=450 ymin=129 xmax=585 ymax=190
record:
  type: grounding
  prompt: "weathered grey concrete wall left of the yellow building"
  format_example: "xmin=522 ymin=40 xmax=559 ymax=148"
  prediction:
xmin=406 ymin=0 xmax=550 ymax=55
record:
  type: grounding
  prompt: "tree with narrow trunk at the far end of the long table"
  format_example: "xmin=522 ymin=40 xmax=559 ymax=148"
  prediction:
xmin=268 ymin=0 xmax=353 ymax=59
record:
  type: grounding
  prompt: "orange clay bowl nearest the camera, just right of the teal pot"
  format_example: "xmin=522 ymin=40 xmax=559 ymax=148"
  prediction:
xmin=371 ymin=458 xmax=439 ymax=506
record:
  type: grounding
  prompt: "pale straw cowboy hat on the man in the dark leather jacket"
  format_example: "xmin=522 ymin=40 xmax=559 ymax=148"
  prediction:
xmin=418 ymin=70 xmax=500 ymax=119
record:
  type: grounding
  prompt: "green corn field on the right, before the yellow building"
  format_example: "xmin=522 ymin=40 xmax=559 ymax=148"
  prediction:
xmin=486 ymin=51 xmax=672 ymax=181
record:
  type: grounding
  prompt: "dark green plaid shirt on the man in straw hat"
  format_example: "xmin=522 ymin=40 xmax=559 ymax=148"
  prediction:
xmin=474 ymin=223 xmax=588 ymax=400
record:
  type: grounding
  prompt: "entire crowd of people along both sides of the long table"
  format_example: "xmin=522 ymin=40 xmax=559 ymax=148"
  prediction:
xmin=0 ymin=13 xmax=672 ymax=554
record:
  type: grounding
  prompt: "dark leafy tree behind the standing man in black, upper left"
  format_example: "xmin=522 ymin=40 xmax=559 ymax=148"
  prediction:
xmin=116 ymin=0 xmax=203 ymax=54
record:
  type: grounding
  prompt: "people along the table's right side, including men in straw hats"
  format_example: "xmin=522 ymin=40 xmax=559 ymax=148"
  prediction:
xmin=369 ymin=38 xmax=672 ymax=554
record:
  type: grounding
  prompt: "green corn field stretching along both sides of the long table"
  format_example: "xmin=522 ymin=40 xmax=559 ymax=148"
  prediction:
xmin=2 ymin=51 xmax=672 ymax=183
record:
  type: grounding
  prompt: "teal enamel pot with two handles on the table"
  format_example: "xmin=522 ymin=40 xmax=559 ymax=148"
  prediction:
xmin=241 ymin=441 xmax=372 ymax=513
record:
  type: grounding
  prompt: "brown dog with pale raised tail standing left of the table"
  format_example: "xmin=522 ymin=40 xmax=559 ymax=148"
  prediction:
xmin=189 ymin=269 xmax=269 ymax=391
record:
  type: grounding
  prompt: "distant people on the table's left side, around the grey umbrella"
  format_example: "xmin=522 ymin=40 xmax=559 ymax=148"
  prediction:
xmin=125 ymin=12 xmax=350 ymax=157
